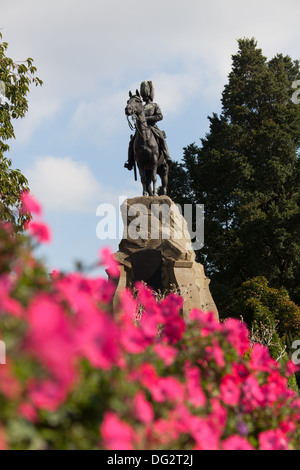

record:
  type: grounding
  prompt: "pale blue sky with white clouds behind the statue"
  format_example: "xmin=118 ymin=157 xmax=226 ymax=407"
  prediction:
xmin=0 ymin=0 xmax=300 ymax=270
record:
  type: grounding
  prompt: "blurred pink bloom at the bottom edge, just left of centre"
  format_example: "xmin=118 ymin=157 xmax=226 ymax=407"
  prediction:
xmin=100 ymin=412 xmax=135 ymax=450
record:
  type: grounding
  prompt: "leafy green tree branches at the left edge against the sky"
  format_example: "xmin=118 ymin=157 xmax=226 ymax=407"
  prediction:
xmin=0 ymin=33 xmax=42 ymax=230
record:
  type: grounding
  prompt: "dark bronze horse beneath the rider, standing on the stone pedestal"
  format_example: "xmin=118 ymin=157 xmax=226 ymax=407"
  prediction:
xmin=125 ymin=90 xmax=169 ymax=196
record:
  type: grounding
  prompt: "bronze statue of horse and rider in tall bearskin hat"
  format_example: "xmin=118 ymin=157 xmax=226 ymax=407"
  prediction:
xmin=124 ymin=81 xmax=172 ymax=196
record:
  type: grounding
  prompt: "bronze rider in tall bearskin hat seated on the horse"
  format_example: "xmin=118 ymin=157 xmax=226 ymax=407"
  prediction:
xmin=124 ymin=81 xmax=172 ymax=170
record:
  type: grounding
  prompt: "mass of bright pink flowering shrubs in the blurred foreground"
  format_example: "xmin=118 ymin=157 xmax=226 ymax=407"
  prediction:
xmin=0 ymin=193 xmax=300 ymax=450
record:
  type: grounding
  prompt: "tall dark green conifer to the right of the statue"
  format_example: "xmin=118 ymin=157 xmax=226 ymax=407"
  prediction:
xmin=170 ymin=39 xmax=300 ymax=317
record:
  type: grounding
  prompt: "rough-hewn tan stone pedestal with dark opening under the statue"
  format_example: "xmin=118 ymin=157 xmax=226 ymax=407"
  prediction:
xmin=115 ymin=196 xmax=218 ymax=317
